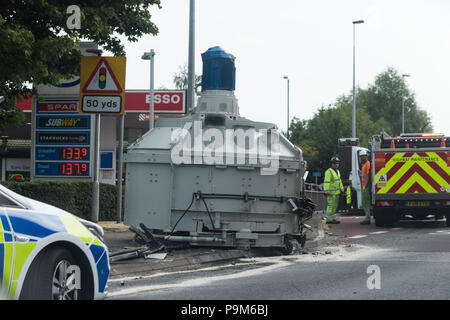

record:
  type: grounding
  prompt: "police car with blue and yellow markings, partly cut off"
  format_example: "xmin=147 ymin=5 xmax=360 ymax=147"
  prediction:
xmin=0 ymin=185 xmax=110 ymax=300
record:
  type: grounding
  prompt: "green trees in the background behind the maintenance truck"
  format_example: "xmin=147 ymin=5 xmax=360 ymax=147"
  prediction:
xmin=290 ymin=68 xmax=431 ymax=171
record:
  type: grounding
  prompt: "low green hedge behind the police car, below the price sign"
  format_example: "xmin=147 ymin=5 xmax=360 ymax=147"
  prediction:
xmin=1 ymin=181 xmax=123 ymax=221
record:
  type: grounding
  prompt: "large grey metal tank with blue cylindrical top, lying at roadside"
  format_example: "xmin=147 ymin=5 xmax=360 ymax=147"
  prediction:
xmin=124 ymin=47 xmax=314 ymax=248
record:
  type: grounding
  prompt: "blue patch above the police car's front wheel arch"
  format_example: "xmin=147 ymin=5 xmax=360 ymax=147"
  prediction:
xmin=8 ymin=210 xmax=66 ymax=238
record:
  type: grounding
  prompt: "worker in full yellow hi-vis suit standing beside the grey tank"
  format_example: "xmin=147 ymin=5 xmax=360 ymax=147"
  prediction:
xmin=323 ymin=157 xmax=344 ymax=224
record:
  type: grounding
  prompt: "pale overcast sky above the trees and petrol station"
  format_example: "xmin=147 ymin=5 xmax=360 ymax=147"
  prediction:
xmin=117 ymin=0 xmax=450 ymax=135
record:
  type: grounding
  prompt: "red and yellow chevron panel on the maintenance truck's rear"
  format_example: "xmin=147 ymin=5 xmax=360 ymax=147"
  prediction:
xmin=374 ymin=151 xmax=450 ymax=195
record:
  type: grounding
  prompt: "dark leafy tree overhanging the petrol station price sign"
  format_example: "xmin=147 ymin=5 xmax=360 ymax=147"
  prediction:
xmin=0 ymin=0 xmax=161 ymax=129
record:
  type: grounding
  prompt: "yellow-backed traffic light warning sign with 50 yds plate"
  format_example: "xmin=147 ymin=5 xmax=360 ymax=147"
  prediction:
xmin=80 ymin=56 xmax=126 ymax=114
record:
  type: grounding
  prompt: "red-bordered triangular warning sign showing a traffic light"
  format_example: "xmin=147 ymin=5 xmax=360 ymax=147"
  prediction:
xmin=82 ymin=58 xmax=122 ymax=94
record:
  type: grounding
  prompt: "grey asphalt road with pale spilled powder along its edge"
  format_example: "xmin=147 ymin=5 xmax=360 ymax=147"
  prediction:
xmin=109 ymin=216 xmax=450 ymax=300
